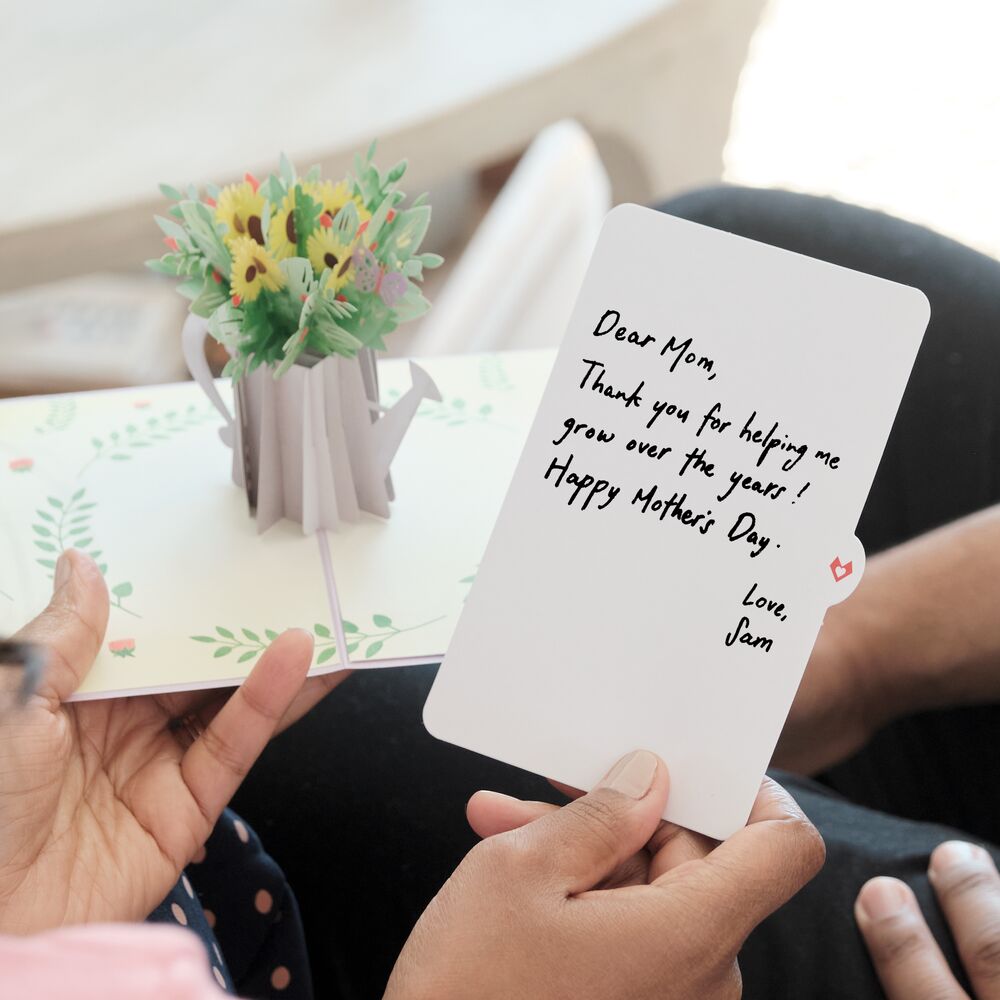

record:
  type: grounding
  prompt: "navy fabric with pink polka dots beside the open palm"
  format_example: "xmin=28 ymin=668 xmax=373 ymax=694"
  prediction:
xmin=147 ymin=809 xmax=313 ymax=1000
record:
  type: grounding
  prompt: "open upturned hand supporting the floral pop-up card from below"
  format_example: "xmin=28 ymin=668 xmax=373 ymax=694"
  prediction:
xmin=0 ymin=551 xmax=343 ymax=934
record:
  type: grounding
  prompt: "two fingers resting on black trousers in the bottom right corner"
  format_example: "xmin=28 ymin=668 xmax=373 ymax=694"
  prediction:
xmin=854 ymin=840 xmax=1000 ymax=1000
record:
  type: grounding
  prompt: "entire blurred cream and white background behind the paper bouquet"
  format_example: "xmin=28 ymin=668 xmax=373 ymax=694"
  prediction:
xmin=0 ymin=0 xmax=1000 ymax=395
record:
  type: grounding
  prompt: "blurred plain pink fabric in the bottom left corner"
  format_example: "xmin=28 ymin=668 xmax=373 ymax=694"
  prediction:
xmin=0 ymin=924 xmax=226 ymax=1000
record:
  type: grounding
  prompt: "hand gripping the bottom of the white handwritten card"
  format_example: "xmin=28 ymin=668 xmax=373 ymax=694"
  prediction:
xmin=385 ymin=751 xmax=824 ymax=1000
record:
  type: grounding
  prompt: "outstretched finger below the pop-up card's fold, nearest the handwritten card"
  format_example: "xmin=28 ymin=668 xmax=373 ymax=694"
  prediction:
xmin=181 ymin=629 xmax=313 ymax=824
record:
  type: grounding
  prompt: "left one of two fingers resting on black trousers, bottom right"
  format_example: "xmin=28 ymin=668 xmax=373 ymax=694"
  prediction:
xmin=854 ymin=876 xmax=969 ymax=1000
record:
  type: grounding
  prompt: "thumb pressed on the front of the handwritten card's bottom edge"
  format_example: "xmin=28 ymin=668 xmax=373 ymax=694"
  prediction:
xmin=515 ymin=750 xmax=670 ymax=895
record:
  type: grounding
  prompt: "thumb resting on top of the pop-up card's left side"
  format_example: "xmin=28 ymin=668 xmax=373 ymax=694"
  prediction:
xmin=14 ymin=549 xmax=108 ymax=708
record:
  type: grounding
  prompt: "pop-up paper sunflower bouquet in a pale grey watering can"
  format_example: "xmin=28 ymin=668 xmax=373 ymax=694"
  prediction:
xmin=148 ymin=143 xmax=442 ymax=532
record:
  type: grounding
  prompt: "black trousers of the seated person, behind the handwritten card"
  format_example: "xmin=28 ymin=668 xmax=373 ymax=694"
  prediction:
xmin=234 ymin=188 xmax=1000 ymax=1000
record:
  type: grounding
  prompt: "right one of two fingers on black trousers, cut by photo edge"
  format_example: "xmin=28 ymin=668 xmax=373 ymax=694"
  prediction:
xmin=927 ymin=840 xmax=1000 ymax=1000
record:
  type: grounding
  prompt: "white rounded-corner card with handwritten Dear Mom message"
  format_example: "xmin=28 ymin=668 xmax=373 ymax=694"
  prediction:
xmin=424 ymin=205 xmax=929 ymax=838
